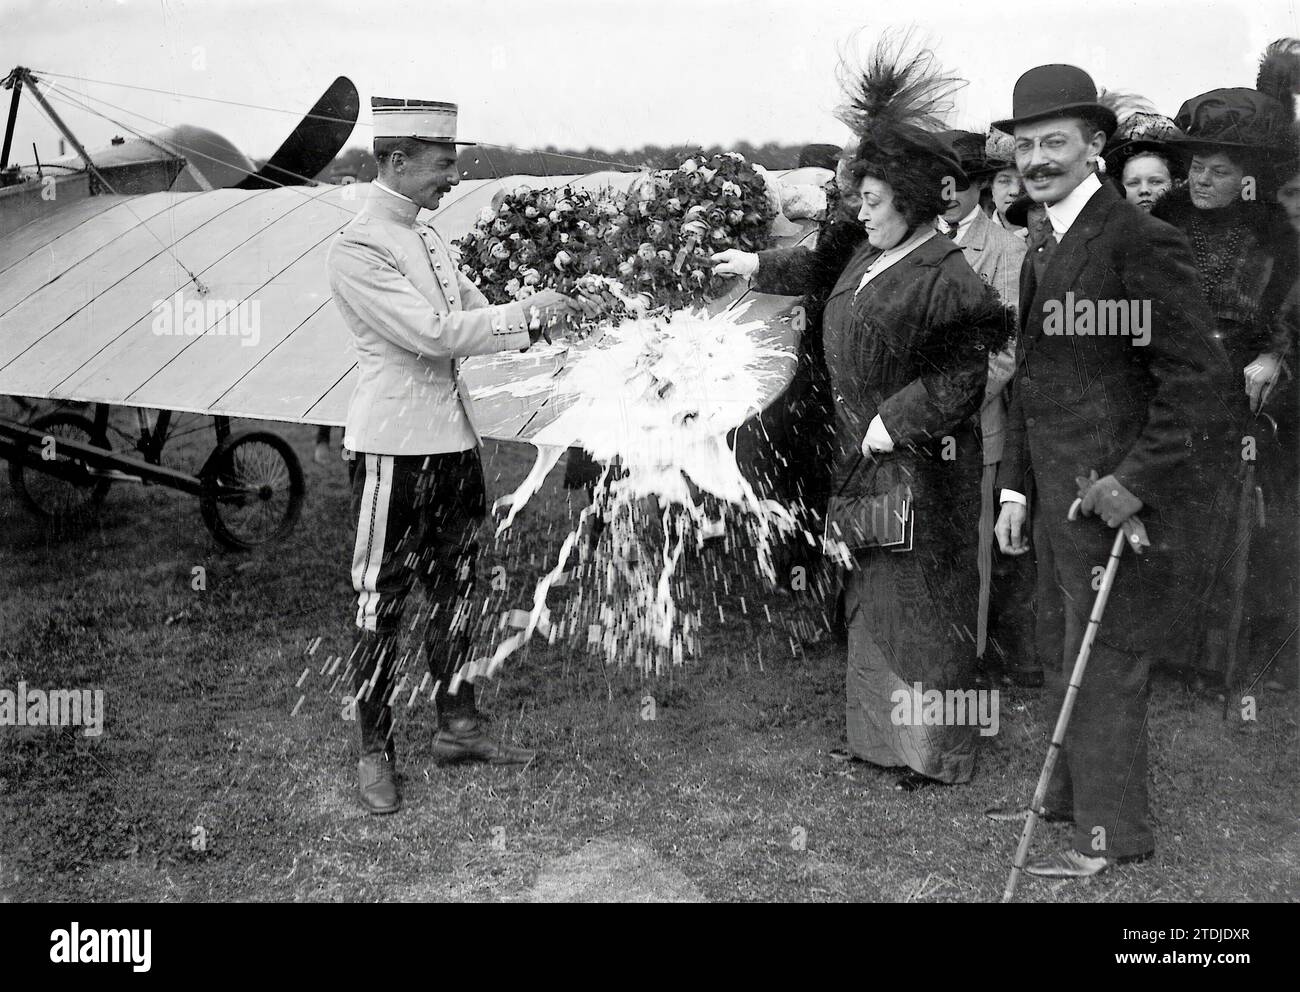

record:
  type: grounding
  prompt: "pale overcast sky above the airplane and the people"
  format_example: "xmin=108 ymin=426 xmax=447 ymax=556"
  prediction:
xmin=0 ymin=0 xmax=1300 ymax=164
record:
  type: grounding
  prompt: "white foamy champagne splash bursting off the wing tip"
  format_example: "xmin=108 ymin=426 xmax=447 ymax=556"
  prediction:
xmin=456 ymin=304 xmax=798 ymax=680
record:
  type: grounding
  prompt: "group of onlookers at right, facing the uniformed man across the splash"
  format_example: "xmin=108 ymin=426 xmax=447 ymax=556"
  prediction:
xmin=718 ymin=39 xmax=1300 ymax=878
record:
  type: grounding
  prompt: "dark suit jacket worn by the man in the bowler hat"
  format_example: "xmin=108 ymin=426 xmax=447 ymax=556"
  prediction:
xmin=998 ymin=183 xmax=1235 ymax=523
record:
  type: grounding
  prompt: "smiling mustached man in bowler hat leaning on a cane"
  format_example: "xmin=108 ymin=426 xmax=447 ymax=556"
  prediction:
xmin=989 ymin=65 xmax=1235 ymax=878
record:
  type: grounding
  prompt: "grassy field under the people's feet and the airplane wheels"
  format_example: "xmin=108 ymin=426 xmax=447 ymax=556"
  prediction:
xmin=0 ymin=416 xmax=1300 ymax=901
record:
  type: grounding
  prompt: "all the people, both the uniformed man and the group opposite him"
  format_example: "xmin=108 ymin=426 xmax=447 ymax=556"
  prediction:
xmin=319 ymin=38 xmax=1300 ymax=878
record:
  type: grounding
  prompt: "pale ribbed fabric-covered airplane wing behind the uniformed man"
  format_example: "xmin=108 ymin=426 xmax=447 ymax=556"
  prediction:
xmin=0 ymin=173 xmax=811 ymax=439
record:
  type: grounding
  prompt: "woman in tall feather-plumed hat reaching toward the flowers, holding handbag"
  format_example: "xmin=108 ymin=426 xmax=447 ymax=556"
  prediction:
xmin=728 ymin=36 xmax=1014 ymax=789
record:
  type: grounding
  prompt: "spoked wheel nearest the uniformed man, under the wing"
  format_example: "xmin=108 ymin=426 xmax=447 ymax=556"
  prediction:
xmin=199 ymin=430 xmax=303 ymax=551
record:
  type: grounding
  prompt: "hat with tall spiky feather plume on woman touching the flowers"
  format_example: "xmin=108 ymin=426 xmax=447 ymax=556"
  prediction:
xmin=836 ymin=33 xmax=966 ymax=183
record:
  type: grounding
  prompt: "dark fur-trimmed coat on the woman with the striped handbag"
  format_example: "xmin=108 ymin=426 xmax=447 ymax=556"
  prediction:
xmin=823 ymin=235 xmax=1015 ymax=696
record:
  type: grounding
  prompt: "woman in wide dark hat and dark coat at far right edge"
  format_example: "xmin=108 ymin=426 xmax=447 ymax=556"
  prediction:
xmin=1152 ymin=56 xmax=1300 ymax=685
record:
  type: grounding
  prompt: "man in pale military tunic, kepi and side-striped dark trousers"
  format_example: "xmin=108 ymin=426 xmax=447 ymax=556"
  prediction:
xmin=328 ymin=98 xmax=594 ymax=814
